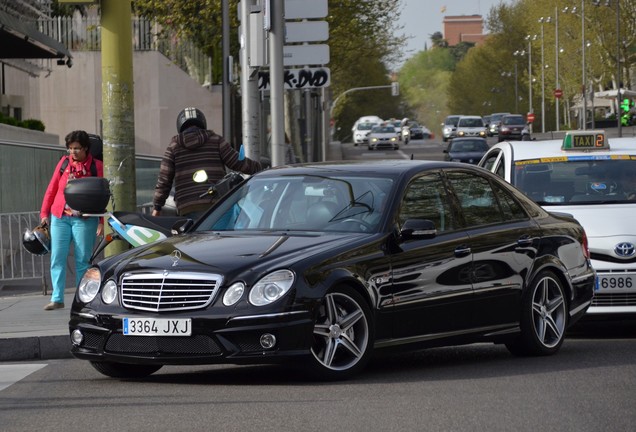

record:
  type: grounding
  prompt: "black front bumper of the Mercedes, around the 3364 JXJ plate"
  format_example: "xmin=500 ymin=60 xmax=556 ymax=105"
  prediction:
xmin=69 ymin=311 xmax=313 ymax=365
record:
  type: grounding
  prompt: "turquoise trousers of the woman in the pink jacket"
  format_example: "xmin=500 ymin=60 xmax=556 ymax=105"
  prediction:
xmin=50 ymin=215 xmax=99 ymax=303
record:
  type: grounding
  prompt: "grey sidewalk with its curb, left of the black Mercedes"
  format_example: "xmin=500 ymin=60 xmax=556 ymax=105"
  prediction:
xmin=0 ymin=288 xmax=75 ymax=362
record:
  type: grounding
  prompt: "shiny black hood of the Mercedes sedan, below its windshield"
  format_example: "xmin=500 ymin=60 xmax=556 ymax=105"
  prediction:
xmin=109 ymin=232 xmax=370 ymax=274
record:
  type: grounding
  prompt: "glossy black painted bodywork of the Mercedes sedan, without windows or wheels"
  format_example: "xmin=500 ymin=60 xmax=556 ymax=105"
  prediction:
xmin=69 ymin=161 xmax=592 ymax=376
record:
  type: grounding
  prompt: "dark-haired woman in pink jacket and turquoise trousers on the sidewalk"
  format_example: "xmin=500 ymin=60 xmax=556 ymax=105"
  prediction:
xmin=40 ymin=130 xmax=104 ymax=310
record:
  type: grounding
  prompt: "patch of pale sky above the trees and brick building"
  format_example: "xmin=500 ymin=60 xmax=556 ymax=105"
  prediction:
xmin=399 ymin=0 xmax=514 ymax=58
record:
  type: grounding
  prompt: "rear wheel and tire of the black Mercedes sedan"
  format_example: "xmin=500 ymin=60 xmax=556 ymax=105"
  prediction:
xmin=506 ymin=271 xmax=568 ymax=356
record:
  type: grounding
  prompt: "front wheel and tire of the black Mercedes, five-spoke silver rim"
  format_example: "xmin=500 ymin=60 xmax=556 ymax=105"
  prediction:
xmin=308 ymin=287 xmax=374 ymax=381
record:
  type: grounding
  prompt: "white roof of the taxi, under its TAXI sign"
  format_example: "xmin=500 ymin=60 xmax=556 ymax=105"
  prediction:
xmin=492 ymin=138 xmax=636 ymax=160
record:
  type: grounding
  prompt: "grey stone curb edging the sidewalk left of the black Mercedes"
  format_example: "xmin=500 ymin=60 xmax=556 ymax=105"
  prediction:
xmin=0 ymin=335 xmax=73 ymax=361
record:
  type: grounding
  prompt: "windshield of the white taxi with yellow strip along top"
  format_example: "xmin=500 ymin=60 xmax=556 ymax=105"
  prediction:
xmin=513 ymin=159 xmax=636 ymax=205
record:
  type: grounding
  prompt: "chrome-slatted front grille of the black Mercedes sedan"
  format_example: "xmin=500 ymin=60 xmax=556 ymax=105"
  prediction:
xmin=121 ymin=272 xmax=223 ymax=312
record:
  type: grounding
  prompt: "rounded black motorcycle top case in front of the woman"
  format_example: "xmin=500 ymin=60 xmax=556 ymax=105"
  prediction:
xmin=64 ymin=177 xmax=110 ymax=213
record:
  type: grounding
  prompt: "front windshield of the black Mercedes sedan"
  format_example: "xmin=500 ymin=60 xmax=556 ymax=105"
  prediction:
xmin=197 ymin=176 xmax=393 ymax=233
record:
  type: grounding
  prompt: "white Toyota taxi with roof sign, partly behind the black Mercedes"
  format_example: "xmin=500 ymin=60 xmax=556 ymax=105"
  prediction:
xmin=478 ymin=130 xmax=636 ymax=317
